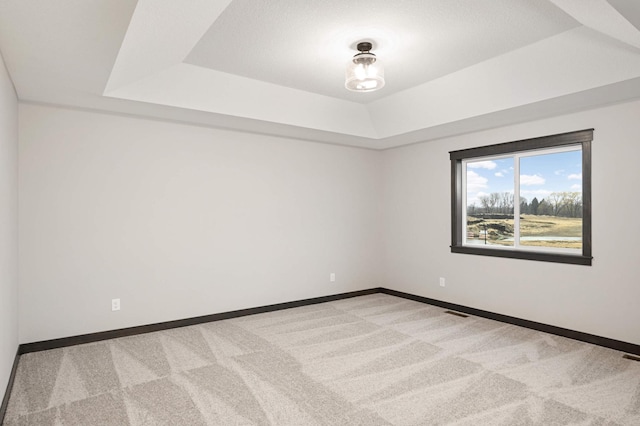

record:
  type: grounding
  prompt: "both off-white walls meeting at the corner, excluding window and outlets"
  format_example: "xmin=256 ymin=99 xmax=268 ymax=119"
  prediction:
xmin=20 ymin=96 xmax=640 ymax=344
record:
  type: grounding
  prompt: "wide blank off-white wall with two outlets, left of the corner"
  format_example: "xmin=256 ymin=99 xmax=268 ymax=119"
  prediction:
xmin=20 ymin=104 xmax=383 ymax=343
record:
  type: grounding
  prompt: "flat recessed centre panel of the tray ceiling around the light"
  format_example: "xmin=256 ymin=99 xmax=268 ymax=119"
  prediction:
xmin=184 ymin=0 xmax=580 ymax=103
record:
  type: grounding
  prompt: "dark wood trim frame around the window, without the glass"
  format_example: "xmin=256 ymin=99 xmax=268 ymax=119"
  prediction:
xmin=449 ymin=129 xmax=594 ymax=265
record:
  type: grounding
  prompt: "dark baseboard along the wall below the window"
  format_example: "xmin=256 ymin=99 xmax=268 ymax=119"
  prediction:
xmin=380 ymin=288 xmax=640 ymax=355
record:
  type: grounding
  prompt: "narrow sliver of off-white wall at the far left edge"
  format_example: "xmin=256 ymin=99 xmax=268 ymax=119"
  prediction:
xmin=0 ymin=55 xmax=18 ymax=400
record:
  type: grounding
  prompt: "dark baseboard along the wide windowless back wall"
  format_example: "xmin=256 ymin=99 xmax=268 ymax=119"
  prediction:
xmin=18 ymin=288 xmax=382 ymax=355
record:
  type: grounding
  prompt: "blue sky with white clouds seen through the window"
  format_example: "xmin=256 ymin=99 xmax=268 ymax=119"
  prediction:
xmin=467 ymin=150 xmax=582 ymax=206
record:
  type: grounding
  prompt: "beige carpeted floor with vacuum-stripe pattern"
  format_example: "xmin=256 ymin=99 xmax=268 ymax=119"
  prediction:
xmin=4 ymin=294 xmax=640 ymax=426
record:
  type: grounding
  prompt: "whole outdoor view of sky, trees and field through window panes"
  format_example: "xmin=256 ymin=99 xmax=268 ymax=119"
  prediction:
xmin=464 ymin=145 xmax=585 ymax=250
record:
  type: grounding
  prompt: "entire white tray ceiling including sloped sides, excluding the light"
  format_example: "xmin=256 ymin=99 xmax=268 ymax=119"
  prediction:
xmin=0 ymin=0 xmax=640 ymax=149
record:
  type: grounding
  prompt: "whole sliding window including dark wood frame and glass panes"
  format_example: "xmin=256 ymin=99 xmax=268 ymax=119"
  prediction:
xmin=449 ymin=129 xmax=593 ymax=265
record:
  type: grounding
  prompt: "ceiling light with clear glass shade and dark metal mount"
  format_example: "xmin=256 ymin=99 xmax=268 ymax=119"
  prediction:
xmin=344 ymin=41 xmax=384 ymax=92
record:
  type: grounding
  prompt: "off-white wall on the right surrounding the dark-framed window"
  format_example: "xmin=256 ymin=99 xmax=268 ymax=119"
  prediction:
xmin=383 ymin=102 xmax=640 ymax=344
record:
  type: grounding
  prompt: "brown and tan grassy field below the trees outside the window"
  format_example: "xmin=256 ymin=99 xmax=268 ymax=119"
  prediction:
xmin=467 ymin=214 xmax=582 ymax=249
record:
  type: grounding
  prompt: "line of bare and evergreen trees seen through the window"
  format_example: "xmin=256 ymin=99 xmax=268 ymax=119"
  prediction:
xmin=467 ymin=192 xmax=582 ymax=217
